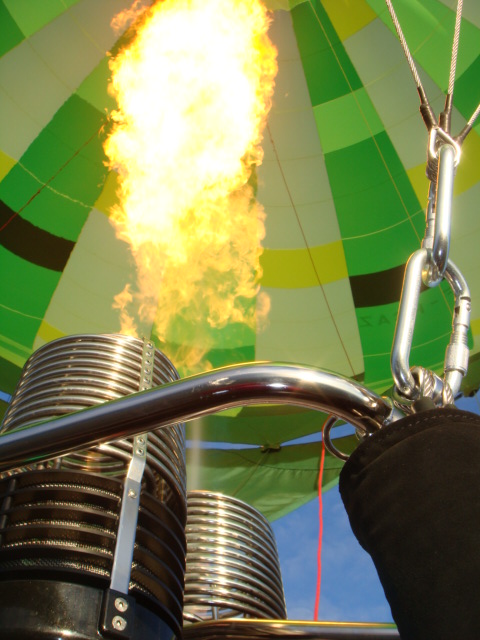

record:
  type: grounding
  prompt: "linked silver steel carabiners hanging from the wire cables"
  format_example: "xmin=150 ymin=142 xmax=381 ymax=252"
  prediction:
xmin=391 ymin=125 xmax=471 ymax=406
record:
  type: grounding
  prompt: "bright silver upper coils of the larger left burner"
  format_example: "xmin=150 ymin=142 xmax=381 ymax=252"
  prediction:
xmin=1 ymin=335 xmax=186 ymax=521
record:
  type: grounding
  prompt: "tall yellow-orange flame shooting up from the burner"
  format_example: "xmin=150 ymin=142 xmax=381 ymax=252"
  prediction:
xmin=105 ymin=0 xmax=277 ymax=370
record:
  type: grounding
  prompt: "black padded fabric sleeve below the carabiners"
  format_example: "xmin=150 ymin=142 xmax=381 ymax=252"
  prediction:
xmin=340 ymin=408 xmax=480 ymax=640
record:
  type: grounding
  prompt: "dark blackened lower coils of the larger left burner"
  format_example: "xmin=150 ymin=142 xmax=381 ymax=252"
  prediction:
xmin=0 ymin=469 xmax=186 ymax=638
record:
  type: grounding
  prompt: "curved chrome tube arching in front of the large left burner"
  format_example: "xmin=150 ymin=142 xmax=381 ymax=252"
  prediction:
xmin=0 ymin=362 xmax=400 ymax=470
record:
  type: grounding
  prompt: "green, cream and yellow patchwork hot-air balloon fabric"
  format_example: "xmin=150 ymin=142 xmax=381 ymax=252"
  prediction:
xmin=0 ymin=0 xmax=480 ymax=518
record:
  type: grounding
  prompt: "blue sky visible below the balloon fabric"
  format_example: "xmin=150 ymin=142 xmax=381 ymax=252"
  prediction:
xmin=272 ymin=397 xmax=480 ymax=622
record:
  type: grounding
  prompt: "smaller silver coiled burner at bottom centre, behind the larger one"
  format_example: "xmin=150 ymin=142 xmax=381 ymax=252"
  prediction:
xmin=183 ymin=491 xmax=286 ymax=622
